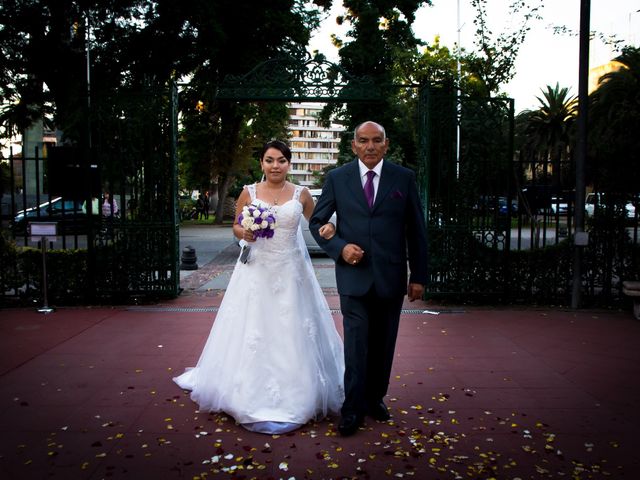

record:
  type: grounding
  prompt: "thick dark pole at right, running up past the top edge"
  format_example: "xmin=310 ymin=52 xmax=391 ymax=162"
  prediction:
xmin=571 ymin=0 xmax=591 ymax=309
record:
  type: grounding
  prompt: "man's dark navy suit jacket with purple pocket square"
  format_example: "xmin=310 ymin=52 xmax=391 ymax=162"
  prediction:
xmin=309 ymin=160 xmax=427 ymax=297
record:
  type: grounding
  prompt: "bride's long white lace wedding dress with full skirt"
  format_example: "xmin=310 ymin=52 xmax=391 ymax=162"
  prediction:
xmin=174 ymin=184 xmax=344 ymax=433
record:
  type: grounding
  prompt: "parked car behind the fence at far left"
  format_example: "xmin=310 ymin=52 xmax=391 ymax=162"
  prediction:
xmin=10 ymin=197 xmax=99 ymax=235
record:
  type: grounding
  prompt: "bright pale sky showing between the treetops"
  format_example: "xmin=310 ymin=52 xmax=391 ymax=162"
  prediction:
xmin=310 ymin=0 xmax=640 ymax=112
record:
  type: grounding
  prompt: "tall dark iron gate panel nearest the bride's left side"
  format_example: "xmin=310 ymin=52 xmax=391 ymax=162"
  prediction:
xmin=90 ymin=84 xmax=180 ymax=299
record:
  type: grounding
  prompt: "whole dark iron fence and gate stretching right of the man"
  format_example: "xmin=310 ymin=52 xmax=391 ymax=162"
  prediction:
xmin=419 ymin=86 xmax=640 ymax=307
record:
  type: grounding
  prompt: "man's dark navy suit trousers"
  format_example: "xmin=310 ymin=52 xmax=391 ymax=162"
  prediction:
xmin=340 ymin=286 xmax=404 ymax=416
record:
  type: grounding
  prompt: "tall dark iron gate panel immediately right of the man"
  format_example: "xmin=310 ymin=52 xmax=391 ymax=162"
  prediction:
xmin=419 ymin=86 xmax=516 ymax=300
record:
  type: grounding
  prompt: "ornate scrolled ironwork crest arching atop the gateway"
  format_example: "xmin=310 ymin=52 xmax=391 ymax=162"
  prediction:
xmin=217 ymin=53 xmax=384 ymax=102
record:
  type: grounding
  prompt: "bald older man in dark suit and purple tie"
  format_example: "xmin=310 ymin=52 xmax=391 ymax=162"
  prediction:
xmin=310 ymin=121 xmax=427 ymax=436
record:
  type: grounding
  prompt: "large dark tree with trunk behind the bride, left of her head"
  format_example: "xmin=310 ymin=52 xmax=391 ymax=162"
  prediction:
xmin=175 ymin=0 xmax=324 ymax=222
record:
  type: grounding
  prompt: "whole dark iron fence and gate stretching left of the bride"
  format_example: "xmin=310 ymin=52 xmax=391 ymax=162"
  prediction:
xmin=0 ymin=85 xmax=179 ymax=303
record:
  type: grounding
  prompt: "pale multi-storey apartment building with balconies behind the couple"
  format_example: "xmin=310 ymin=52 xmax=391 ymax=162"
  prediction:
xmin=288 ymin=103 xmax=344 ymax=187
